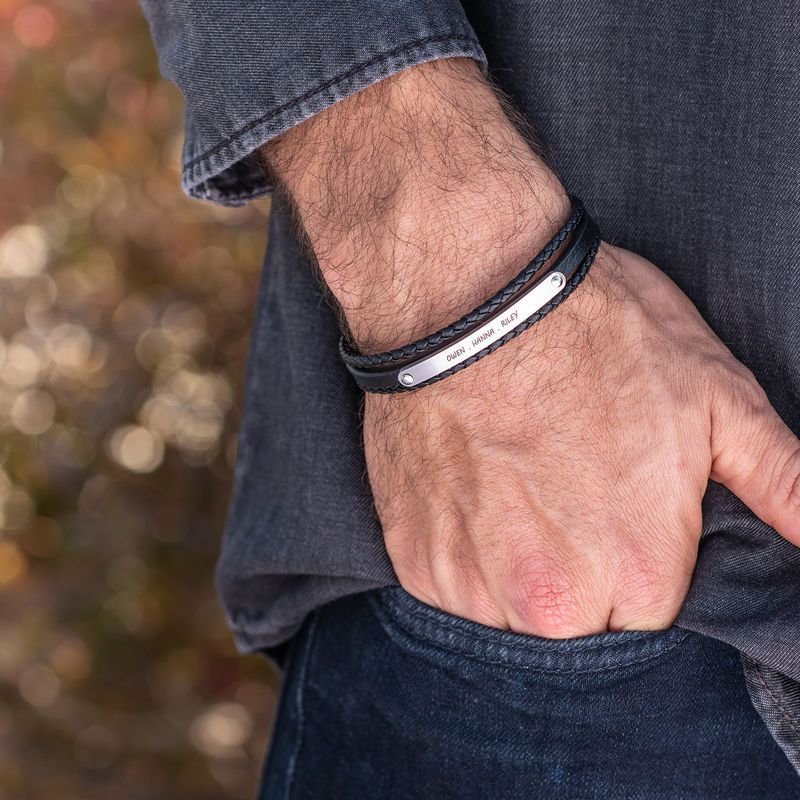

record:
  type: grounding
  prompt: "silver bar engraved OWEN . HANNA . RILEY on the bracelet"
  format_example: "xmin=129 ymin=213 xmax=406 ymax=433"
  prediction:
xmin=398 ymin=272 xmax=566 ymax=386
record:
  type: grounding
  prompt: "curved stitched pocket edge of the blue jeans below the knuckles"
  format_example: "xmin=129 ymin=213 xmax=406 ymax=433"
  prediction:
xmin=373 ymin=586 xmax=691 ymax=674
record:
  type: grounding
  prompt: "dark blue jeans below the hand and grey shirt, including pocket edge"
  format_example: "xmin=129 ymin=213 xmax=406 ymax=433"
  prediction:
xmin=261 ymin=587 xmax=800 ymax=800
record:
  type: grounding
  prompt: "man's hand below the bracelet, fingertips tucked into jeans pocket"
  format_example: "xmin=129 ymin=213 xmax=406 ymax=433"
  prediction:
xmin=365 ymin=245 xmax=800 ymax=638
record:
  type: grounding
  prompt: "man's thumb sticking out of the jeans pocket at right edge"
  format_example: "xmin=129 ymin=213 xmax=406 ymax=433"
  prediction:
xmin=711 ymin=378 xmax=800 ymax=546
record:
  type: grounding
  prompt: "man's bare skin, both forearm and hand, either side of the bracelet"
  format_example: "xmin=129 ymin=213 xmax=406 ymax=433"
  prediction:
xmin=263 ymin=59 xmax=800 ymax=638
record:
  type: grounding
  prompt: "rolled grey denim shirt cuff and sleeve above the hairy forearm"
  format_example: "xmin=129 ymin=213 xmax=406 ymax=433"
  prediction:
xmin=141 ymin=0 xmax=486 ymax=205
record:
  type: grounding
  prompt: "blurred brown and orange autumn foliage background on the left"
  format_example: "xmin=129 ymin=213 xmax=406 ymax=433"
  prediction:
xmin=0 ymin=0 xmax=278 ymax=800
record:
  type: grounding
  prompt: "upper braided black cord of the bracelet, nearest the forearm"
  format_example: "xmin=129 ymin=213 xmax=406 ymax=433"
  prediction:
xmin=339 ymin=197 xmax=585 ymax=370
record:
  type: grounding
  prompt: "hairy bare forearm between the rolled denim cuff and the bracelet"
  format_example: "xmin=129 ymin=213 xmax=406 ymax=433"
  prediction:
xmin=264 ymin=59 xmax=569 ymax=350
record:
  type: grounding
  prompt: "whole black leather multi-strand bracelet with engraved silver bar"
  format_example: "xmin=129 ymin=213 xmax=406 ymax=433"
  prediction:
xmin=339 ymin=197 xmax=600 ymax=393
